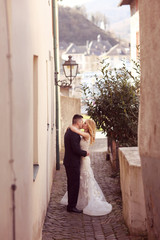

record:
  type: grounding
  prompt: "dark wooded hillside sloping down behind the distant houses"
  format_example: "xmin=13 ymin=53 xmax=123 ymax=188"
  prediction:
xmin=59 ymin=6 xmax=117 ymax=46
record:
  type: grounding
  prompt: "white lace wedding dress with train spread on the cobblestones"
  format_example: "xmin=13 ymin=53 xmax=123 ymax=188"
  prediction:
xmin=61 ymin=138 xmax=112 ymax=216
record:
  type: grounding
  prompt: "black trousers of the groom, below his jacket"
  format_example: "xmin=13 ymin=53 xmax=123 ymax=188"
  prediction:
xmin=65 ymin=166 xmax=80 ymax=209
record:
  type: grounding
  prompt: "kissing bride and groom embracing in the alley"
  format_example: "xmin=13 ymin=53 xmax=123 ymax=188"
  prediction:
xmin=61 ymin=114 xmax=112 ymax=216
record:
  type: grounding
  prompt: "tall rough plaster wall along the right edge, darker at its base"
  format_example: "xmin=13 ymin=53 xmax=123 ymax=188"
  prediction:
xmin=139 ymin=0 xmax=160 ymax=240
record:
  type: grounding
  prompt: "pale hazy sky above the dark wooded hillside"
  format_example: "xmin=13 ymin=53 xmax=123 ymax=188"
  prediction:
xmin=58 ymin=0 xmax=130 ymax=40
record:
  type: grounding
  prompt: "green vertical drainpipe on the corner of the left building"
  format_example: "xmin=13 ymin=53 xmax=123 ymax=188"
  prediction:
xmin=52 ymin=0 xmax=60 ymax=170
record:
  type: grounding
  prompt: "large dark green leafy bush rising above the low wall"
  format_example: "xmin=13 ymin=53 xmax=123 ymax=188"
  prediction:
xmin=83 ymin=61 xmax=140 ymax=146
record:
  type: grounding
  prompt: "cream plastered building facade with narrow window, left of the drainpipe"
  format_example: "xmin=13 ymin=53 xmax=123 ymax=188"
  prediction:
xmin=0 ymin=0 xmax=56 ymax=240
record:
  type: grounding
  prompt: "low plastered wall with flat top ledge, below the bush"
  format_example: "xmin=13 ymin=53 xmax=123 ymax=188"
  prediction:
xmin=119 ymin=147 xmax=147 ymax=235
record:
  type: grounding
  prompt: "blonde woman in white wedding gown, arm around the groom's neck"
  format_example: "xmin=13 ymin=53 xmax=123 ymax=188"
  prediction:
xmin=61 ymin=119 xmax=112 ymax=216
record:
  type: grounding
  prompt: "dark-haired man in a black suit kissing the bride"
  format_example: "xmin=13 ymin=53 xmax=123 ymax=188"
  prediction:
xmin=63 ymin=114 xmax=88 ymax=213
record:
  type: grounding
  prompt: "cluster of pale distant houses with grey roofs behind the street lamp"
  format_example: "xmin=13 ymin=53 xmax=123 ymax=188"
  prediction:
xmin=60 ymin=35 xmax=130 ymax=105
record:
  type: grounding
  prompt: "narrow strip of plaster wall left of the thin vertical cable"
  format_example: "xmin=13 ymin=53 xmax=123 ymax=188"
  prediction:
xmin=0 ymin=1 xmax=13 ymax=240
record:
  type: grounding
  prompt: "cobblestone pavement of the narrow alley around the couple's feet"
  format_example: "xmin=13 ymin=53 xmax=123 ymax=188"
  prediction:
xmin=42 ymin=139 xmax=146 ymax=240
